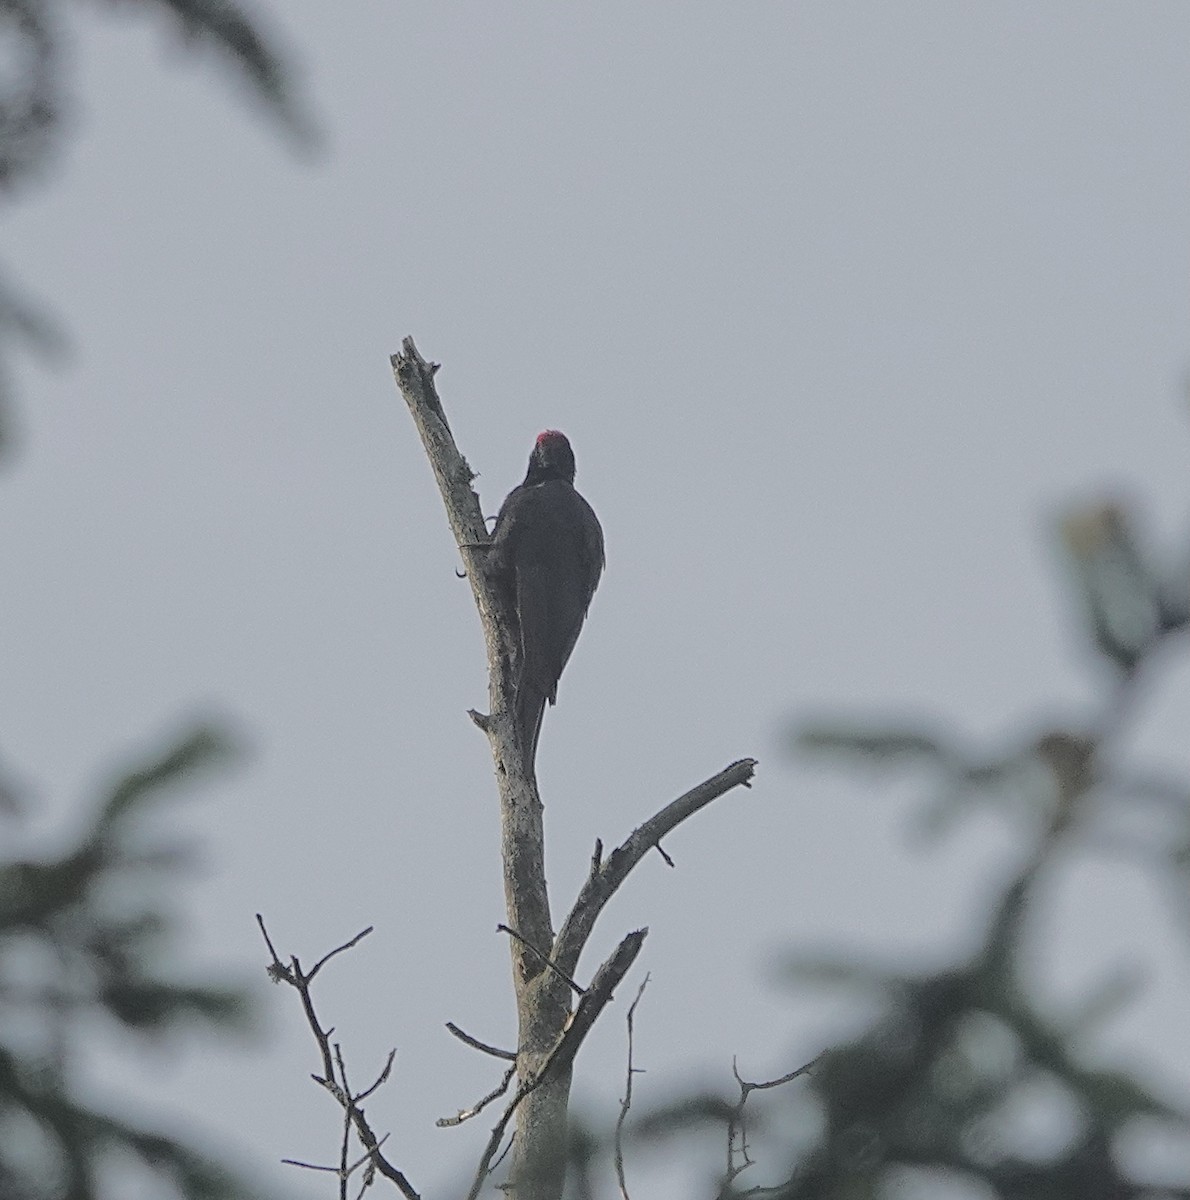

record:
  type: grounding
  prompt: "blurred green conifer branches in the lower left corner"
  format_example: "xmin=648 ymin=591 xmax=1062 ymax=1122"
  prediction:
xmin=0 ymin=727 xmax=262 ymax=1200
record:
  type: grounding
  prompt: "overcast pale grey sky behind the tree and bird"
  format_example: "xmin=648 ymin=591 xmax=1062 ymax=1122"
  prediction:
xmin=0 ymin=0 xmax=1190 ymax=1196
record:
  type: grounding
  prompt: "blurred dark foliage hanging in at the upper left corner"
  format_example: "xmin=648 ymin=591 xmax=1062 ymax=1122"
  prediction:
xmin=0 ymin=0 xmax=314 ymax=450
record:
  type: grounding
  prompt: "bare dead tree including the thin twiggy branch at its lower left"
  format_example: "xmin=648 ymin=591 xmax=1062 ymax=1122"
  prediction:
xmin=262 ymin=337 xmax=756 ymax=1200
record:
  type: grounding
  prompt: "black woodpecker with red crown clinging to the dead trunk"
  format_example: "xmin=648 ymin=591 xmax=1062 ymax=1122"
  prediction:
xmin=487 ymin=430 xmax=603 ymax=779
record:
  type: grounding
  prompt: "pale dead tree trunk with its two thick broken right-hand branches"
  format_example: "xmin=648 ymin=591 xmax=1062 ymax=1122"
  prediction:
xmin=392 ymin=337 xmax=756 ymax=1200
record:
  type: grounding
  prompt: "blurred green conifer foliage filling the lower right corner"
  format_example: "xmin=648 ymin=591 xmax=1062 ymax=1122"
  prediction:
xmin=587 ymin=487 xmax=1190 ymax=1200
